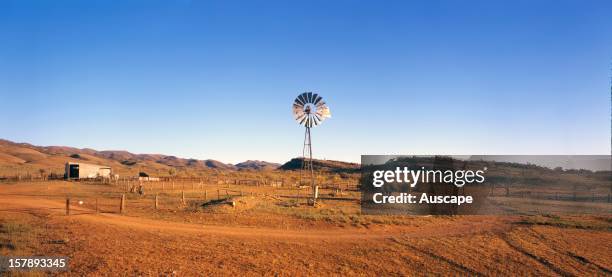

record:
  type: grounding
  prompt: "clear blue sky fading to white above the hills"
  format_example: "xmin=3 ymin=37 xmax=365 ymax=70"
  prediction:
xmin=0 ymin=0 xmax=612 ymax=163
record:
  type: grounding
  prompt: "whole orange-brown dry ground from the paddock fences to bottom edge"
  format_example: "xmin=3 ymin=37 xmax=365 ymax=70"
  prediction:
xmin=0 ymin=179 xmax=612 ymax=276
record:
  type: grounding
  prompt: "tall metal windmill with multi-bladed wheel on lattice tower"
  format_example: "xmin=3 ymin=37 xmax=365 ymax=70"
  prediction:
xmin=293 ymin=92 xmax=331 ymax=204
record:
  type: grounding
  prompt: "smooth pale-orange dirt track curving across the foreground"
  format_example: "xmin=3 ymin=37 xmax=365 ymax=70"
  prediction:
xmin=0 ymin=192 xmax=510 ymax=241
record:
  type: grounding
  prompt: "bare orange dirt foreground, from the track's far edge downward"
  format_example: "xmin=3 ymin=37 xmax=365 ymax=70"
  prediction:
xmin=0 ymin=183 xmax=612 ymax=276
